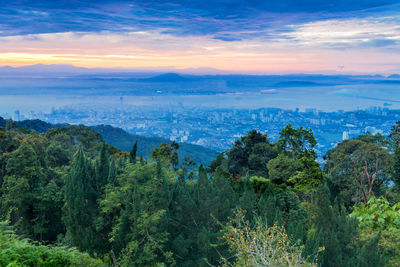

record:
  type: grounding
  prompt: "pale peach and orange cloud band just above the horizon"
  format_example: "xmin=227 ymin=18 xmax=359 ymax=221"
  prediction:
xmin=0 ymin=26 xmax=400 ymax=72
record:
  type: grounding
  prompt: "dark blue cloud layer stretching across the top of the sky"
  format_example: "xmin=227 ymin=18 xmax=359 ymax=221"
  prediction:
xmin=0 ymin=0 xmax=399 ymax=40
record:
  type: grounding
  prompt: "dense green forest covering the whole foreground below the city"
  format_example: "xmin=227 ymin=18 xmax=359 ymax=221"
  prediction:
xmin=0 ymin=122 xmax=400 ymax=267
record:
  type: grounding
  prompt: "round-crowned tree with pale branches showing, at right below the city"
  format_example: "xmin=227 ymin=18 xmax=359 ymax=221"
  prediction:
xmin=324 ymin=137 xmax=392 ymax=208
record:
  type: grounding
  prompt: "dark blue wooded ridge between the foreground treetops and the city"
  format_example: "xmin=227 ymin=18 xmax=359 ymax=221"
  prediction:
xmin=0 ymin=117 xmax=217 ymax=166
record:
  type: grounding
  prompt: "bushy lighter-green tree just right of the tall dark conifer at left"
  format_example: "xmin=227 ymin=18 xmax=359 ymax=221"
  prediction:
xmin=100 ymin=162 xmax=175 ymax=266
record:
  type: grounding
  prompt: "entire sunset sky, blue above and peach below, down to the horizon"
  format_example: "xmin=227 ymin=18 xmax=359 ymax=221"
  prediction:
xmin=0 ymin=0 xmax=400 ymax=74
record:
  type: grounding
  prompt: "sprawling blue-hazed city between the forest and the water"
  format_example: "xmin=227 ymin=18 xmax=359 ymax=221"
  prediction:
xmin=0 ymin=104 xmax=400 ymax=159
